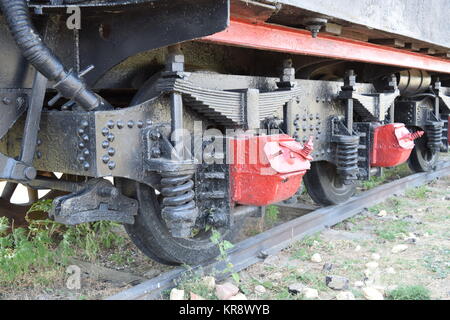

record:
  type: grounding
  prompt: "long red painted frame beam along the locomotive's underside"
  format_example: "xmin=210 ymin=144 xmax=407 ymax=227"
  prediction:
xmin=201 ymin=18 xmax=450 ymax=73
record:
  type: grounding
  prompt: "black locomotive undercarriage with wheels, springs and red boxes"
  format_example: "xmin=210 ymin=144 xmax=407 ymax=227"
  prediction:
xmin=0 ymin=0 xmax=450 ymax=264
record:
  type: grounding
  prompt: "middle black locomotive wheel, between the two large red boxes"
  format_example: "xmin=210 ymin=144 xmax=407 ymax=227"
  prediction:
xmin=304 ymin=161 xmax=356 ymax=206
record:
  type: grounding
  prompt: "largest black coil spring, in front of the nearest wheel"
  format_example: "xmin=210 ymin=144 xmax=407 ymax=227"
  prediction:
xmin=161 ymin=173 xmax=198 ymax=238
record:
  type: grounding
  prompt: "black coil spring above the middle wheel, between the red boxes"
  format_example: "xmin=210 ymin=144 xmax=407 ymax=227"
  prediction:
xmin=336 ymin=136 xmax=359 ymax=183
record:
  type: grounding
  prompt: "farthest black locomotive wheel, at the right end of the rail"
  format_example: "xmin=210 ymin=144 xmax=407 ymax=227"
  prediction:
xmin=408 ymin=134 xmax=439 ymax=172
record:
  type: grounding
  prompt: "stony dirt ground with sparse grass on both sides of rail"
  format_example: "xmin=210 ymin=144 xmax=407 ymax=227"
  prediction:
xmin=0 ymin=155 xmax=450 ymax=300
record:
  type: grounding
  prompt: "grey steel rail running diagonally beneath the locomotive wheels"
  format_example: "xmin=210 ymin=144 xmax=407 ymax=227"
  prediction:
xmin=106 ymin=161 xmax=450 ymax=300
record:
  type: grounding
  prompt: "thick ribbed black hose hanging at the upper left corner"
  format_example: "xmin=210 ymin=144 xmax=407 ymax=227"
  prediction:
xmin=0 ymin=0 xmax=111 ymax=110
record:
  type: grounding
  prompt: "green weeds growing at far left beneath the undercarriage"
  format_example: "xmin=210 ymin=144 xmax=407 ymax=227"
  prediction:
xmin=0 ymin=200 xmax=125 ymax=286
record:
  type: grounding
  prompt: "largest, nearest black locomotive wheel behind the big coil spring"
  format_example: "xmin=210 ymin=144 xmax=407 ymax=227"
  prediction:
xmin=121 ymin=180 xmax=237 ymax=265
